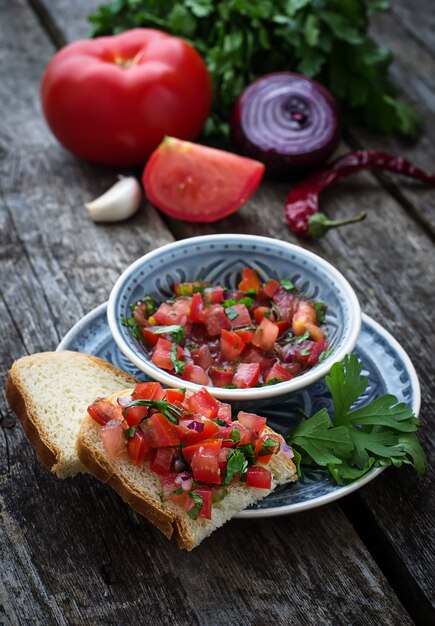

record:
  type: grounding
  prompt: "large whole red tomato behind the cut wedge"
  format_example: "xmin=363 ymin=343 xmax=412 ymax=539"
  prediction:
xmin=41 ymin=28 xmax=211 ymax=166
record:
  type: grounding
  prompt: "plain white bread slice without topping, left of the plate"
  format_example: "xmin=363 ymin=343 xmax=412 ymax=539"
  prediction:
xmin=6 ymin=351 xmax=137 ymax=478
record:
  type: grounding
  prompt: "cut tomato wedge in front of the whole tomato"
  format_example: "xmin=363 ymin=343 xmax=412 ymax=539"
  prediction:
xmin=142 ymin=137 xmax=264 ymax=222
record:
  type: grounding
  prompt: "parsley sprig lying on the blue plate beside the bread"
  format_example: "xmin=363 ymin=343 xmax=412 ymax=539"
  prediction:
xmin=288 ymin=354 xmax=426 ymax=484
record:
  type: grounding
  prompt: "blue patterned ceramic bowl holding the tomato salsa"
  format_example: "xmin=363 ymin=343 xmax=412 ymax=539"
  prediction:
xmin=107 ymin=234 xmax=361 ymax=408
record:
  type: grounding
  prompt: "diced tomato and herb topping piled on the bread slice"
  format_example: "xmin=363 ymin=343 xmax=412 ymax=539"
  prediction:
xmin=88 ymin=380 xmax=289 ymax=519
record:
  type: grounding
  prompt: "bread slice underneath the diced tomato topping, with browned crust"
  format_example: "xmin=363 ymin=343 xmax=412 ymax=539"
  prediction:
xmin=77 ymin=389 xmax=297 ymax=550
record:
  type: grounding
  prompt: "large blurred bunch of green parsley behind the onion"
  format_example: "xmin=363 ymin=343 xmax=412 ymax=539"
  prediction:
xmin=89 ymin=0 xmax=418 ymax=136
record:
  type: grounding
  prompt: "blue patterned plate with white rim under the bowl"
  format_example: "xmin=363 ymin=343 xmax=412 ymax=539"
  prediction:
xmin=57 ymin=303 xmax=420 ymax=518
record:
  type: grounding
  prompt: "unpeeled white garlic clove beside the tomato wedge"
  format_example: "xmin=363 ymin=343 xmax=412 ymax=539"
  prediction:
xmin=85 ymin=176 xmax=142 ymax=222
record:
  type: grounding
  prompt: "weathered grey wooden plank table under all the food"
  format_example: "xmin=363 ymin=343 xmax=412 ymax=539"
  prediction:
xmin=0 ymin=0 xmax=435 ymax=626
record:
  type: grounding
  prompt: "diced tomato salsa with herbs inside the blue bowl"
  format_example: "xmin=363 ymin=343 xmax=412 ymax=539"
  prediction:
xmin=124 ymin=268 xmax=329 ymax=389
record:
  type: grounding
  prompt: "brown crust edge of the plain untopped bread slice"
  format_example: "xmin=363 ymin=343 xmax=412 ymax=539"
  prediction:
xmin=6 ymin=350 xmax=138 ymax=471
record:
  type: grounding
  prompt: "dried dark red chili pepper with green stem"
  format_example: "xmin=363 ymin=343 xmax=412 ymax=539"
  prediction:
xmin=285 ymin=150 xmax=435 ymax=238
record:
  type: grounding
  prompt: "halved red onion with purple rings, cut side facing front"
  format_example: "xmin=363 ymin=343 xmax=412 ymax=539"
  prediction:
xmin=232 ymin=72 xmax=341 ymax=175
